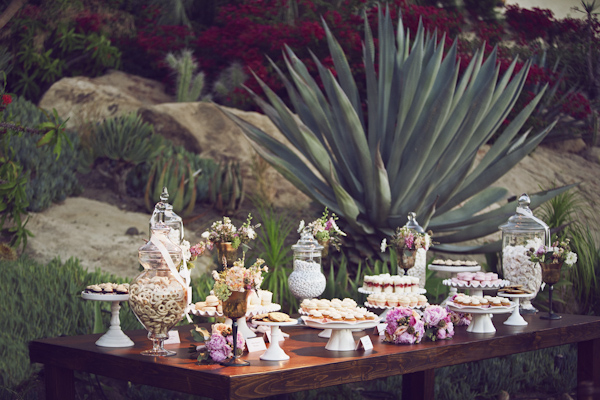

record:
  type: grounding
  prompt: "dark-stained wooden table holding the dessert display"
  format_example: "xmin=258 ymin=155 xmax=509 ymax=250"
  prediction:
xmin=29 ymin=315 xmax=600 ymax=400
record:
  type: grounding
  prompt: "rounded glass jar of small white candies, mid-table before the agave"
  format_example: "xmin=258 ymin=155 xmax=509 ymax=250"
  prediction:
xmin=288 ymin=227 xmax=326 ymax=299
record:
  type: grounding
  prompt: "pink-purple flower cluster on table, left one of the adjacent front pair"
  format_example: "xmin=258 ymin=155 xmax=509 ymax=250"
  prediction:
xmin=384 ymin=307 xmax=425 ymax=344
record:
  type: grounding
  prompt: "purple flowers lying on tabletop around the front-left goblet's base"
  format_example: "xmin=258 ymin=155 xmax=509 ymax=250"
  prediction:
xmin=190 ymin=323 xmax=246 ymax=362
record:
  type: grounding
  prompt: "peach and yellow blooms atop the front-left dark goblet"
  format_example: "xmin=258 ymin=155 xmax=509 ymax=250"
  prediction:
xmin=213 ymin=258 xmax=269 ymax=301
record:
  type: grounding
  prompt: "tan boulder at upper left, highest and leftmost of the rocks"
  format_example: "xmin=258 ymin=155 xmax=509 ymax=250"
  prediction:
xmin=38 ymin=71 xmax=173 ymax=130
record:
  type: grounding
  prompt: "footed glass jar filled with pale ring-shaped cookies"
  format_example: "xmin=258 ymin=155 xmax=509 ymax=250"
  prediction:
xmin=129 ymin=222 xmax=188 ymax=356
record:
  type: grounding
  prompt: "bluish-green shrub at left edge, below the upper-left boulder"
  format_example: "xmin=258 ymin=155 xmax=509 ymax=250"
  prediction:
xmin=3 ymin=98 xmax=82 ymax=212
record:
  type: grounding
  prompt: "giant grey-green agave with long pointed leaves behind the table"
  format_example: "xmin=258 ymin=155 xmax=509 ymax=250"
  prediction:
xmin=222 ymin=11 xmax=564 ymax=255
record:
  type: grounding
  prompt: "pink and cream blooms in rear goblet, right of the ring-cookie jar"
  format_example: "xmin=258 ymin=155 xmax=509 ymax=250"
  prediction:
xmin=190 ymin=214 xmax=260 ymax=261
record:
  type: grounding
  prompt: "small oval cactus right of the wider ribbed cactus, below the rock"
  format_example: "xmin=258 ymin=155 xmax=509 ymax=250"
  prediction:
xmin=210 ymin=161 xmax=244 ymax=214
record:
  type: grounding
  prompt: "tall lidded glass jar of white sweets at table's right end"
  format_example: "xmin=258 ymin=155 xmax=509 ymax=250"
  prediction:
xmin=499 ymin=194 xmax=550 ymax=314
